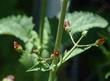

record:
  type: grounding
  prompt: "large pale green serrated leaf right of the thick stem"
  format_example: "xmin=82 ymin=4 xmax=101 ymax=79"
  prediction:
xmin=66 ymin=11 xmax=108 ymax=34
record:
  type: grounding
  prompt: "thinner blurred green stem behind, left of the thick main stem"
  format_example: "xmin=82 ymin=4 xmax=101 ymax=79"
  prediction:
xmin=39 ymin=0 xmax=47 ymax=54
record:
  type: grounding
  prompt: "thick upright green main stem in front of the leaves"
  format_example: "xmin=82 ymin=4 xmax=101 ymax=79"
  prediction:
xmin=48 ymin=0 xmax=68 ymax=81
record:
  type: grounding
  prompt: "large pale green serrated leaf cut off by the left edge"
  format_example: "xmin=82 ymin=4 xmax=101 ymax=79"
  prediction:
xmin=0 ymin=15 xmax=34 ymax=42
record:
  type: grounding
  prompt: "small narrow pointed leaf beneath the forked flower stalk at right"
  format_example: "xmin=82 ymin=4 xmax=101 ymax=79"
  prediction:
xmin=63 ymin=46 xmax=91 ymax=62
